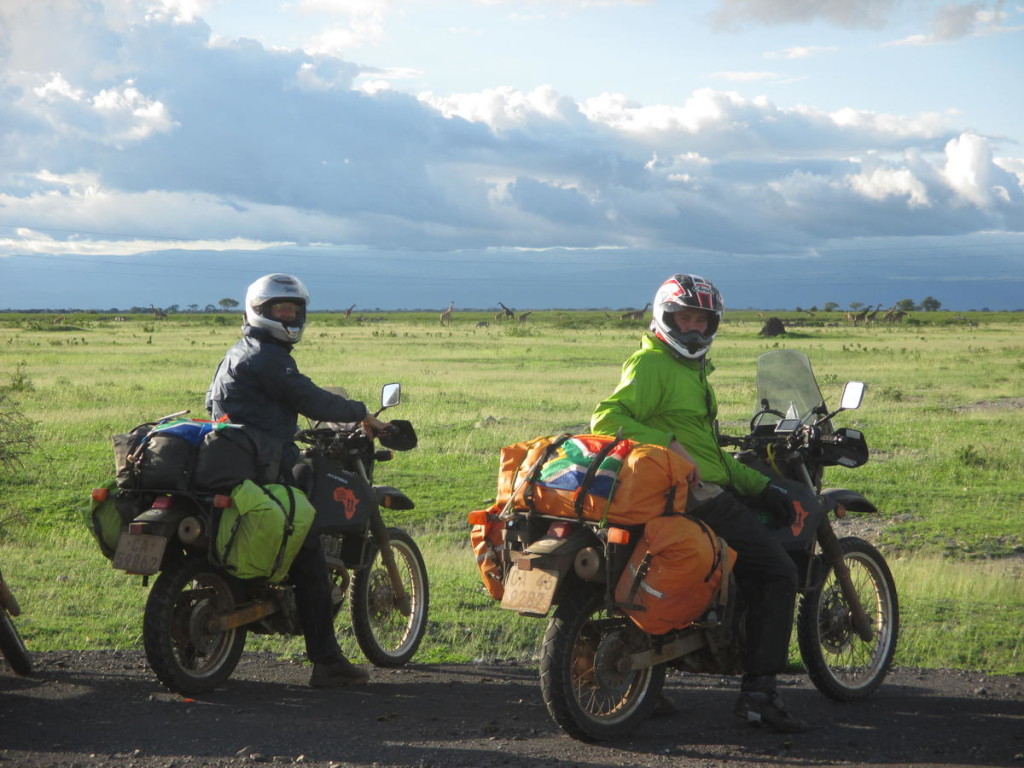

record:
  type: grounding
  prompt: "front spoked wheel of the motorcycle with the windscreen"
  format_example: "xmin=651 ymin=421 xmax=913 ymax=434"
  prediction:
xmin=797 ymin=537 xmax=899 ymax=701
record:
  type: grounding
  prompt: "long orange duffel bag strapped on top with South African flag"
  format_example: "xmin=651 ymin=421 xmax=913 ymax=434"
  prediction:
xmin=497 ymin=434 xmax=692 ymax=525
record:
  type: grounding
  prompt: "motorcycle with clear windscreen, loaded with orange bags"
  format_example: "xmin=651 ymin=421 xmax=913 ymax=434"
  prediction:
xmin=492 ymin=350 xmax=899 ymax=740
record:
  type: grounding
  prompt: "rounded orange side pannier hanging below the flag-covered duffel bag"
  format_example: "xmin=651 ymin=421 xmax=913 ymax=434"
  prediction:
xmin=615 ymin=515 xmax=736 ymax=635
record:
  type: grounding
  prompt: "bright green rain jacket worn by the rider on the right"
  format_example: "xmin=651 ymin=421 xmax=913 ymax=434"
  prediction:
xmin=590 ymin=334 xmax=768 ymax=496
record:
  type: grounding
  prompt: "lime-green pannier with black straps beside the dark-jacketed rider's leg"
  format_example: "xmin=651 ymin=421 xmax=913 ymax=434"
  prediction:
xmin=213 ymin=480 xmax=316 ymax=582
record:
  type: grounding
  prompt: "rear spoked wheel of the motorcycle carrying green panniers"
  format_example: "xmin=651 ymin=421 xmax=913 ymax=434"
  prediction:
xmin=142 ymin=557 xmax=246 ymax=695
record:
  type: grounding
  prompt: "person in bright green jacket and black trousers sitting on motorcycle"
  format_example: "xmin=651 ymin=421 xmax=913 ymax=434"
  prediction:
xmin=591 ymin=274 xmax=808 ymax=733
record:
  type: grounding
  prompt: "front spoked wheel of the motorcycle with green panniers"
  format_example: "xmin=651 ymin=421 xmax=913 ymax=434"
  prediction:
xmin=351 ymin=528 xmax=430 ymax=667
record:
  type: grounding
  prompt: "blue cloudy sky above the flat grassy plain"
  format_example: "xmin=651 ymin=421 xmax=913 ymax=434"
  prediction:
xmin=0 ymin=0 xmax=1024 ymax=310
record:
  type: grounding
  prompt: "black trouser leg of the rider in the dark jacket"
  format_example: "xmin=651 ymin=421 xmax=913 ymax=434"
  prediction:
xmin=289 ymin=534 xmax=344 ymax=664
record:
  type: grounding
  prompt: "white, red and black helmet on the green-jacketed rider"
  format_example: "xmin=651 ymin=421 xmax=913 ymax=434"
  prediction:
xmin=650 ymin=274 xmax=725 ymax=359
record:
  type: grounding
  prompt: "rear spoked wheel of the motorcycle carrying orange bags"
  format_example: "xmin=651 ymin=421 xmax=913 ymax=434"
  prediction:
xmin=541 ymin=589 xmax=666 ymax=741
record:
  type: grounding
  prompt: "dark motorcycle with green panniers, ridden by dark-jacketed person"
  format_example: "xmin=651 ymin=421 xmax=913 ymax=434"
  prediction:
xmin=100 ymin=384 xmax=429 ymax=695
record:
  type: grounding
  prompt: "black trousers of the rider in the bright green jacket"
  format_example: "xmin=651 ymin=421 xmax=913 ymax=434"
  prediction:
xmin=687 ymin=492 xmax=797 ymax=676
